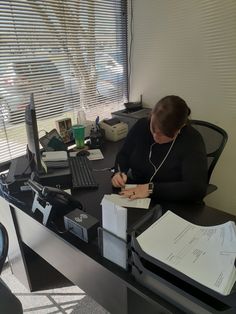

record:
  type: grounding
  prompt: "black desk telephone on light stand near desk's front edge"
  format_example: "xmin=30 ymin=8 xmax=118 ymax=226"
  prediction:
xmin=28 ymin=179 xmax=83 ymax=225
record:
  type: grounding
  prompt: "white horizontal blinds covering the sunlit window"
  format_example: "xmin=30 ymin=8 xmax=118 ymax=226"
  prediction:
xmin=0 ymin=0 xmax=127 ymax=166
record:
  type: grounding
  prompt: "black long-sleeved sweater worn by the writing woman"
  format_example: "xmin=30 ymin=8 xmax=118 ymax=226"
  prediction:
xmin=116 ymin=118 xmax=207 ymax=201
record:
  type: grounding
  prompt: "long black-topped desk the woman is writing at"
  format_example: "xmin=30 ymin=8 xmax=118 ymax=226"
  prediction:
xmin=0 ymin=143 xmax=235 ymax=314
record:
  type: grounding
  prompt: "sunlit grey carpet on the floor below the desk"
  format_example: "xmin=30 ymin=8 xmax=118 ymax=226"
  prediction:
xmin=1 ymin=266 xmax=109 ymax=314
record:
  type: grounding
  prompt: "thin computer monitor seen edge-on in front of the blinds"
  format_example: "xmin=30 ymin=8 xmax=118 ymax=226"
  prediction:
xmin=25 ymin=93 xmax=45 ymax=174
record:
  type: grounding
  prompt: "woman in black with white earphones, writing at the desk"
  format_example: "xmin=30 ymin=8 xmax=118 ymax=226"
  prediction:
xmin=112 ymin=95 xmax=207 ymax=202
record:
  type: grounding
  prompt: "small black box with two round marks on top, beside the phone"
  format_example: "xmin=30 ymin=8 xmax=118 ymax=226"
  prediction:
xmin=64 ymin=209 xmax=99 ymax=243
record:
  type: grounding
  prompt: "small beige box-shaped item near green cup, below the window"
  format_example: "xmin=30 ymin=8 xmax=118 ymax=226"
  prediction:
xmin=99 ymin=118 xmax=128 ymax=142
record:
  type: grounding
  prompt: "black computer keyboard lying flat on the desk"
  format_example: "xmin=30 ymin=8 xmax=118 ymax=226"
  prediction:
xmin=69 ymin=156 xmax=98 ymax=188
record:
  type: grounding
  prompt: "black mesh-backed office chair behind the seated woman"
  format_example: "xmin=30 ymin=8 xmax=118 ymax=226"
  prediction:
xmin=190 ymin=120 xmax=228 ymax=195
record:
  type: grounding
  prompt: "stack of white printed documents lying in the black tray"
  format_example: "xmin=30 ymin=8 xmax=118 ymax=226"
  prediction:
xmin=137 ymin=211 xmax=236 ymax=295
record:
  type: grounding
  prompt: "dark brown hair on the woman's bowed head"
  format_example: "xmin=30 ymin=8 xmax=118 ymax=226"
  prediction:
xmin=152 ymin=95 xmax=191 ymax=137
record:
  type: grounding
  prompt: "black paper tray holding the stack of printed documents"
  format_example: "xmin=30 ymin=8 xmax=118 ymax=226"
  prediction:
xmin=131 ymin=213 xmax=236 ymax=314
